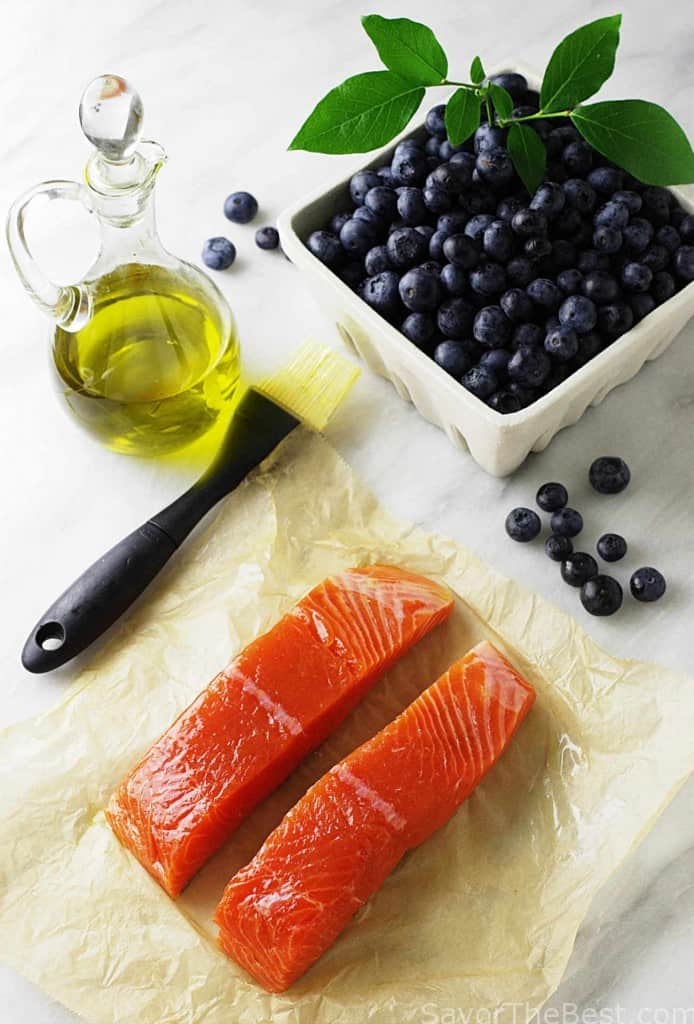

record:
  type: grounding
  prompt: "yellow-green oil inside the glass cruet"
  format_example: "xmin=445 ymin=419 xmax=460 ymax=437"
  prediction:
xmin=53 ymin=263 xmax=240 ymax=455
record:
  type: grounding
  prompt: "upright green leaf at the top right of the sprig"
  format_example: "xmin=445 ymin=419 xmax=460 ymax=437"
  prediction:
xmin=539 ymin=14 xmax=621 ymax=112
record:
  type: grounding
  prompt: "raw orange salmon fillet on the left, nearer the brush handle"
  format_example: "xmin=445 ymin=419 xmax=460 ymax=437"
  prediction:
xmin=106 ymin=565 xmax=452 ymax=896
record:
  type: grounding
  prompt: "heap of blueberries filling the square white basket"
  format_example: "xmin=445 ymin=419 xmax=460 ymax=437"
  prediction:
xmin=306 ymin=74 xmax=694 ymax=413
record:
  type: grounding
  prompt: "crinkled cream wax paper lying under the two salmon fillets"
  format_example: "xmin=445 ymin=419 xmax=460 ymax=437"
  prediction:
xmin=0 ymin=431 xmax=694 ymax=1024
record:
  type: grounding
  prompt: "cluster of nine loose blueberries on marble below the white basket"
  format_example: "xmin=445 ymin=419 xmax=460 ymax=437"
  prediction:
xmin=506 ymin=456 xmax=665 ymax=615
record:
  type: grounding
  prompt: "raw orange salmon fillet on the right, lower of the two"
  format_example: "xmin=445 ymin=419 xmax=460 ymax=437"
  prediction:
xmin=216 ymin=643 xmax=535 ymax=992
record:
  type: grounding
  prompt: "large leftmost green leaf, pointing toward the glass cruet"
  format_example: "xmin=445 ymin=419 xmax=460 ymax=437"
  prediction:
xmin=290 ymin=71 xmax=425 ymax=153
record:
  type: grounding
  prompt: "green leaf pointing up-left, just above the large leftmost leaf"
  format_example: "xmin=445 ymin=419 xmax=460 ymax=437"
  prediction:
xmin=361 ymin=14 xmax=448 ymax=85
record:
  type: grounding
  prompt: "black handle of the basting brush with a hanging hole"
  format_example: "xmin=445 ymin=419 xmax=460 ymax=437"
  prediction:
xmin=21 ymin=390 xmax=298 ymax=672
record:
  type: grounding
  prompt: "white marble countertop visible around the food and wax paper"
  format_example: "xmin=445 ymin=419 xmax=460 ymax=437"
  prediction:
xmin=0 ymin=0 xmax=694 ymax=1024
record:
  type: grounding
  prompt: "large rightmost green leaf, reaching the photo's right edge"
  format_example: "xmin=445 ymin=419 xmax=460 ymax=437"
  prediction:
xmin=571 ymin=99 xmax=694 ymax=185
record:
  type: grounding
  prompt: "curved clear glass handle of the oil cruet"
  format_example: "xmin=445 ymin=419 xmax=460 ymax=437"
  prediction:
xmin=7 ymin=181 xmax=92 ymax=332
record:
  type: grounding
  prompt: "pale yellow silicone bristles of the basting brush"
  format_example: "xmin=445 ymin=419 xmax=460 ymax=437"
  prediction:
xmin=255 ymin=339 xmax=359 ymax=430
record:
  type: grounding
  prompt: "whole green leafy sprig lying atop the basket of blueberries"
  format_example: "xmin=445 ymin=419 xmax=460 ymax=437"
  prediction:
xmin=290 ymin=14 xmax=694 ymax=193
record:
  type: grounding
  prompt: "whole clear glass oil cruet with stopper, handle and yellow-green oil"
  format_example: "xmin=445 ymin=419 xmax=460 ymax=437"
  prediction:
xmin=7 ymin=75 xmax=240 ymax=455
